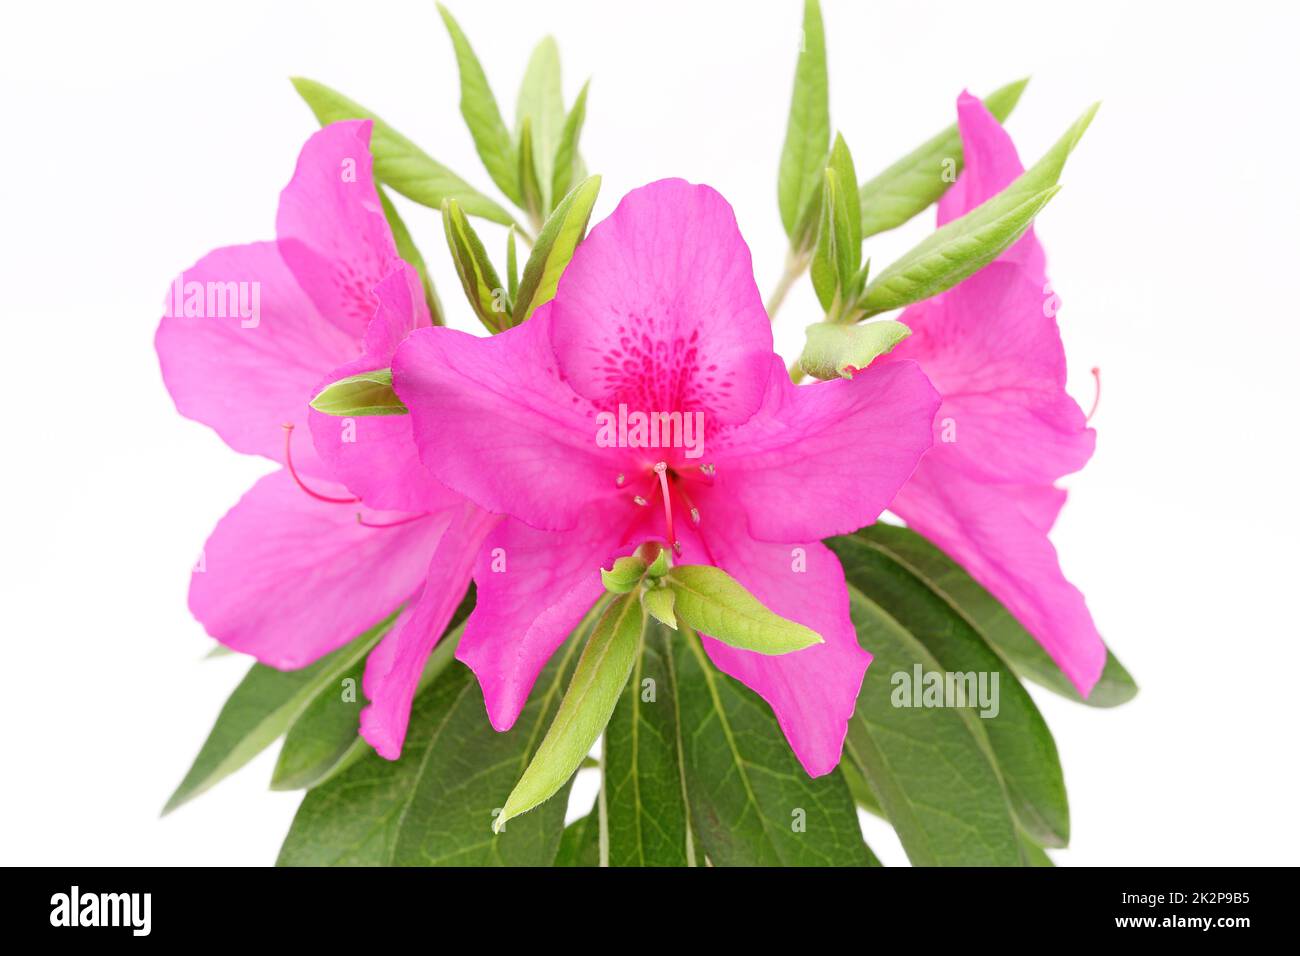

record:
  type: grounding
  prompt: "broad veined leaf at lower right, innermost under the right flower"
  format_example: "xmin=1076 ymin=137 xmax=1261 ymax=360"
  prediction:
xmin=844 ymin=585 xmax=1021 ymax=866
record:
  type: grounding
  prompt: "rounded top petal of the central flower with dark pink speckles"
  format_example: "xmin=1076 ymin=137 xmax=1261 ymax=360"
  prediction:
xmin=551 ymin=179 xmax=772 ymax=423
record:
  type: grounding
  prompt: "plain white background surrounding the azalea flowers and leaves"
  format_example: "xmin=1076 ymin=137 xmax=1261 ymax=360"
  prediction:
xmin=0 ymin=0 xmax=1300 ymax=865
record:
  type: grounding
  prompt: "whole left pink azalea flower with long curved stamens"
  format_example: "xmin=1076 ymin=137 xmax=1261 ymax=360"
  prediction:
xmin=155 ymin=121 xmax=495 ymax=758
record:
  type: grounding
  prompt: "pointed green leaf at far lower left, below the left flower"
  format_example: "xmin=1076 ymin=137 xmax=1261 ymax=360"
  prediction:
xmin=163 ymin=614 xmax=397 ymax=816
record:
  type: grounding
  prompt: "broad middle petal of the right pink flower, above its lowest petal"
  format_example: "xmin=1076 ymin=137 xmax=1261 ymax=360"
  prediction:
xmin=883 ymin=261 xmax=1096 ymax=484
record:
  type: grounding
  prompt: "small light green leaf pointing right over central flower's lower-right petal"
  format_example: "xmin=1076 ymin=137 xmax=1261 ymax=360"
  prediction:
xmin=663 ymin=564 xmax=824 ymax=654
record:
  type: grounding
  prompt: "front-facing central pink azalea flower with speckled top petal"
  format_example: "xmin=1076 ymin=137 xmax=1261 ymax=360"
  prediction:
xmin=393 ymin=179 xmax=939 ymax=775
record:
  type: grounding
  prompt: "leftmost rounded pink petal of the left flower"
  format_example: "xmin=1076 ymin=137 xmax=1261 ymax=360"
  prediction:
xmin=155 ymin=242 xmax=358 ymax=475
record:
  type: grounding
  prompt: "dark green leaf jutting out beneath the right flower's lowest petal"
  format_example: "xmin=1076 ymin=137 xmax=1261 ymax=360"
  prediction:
xmin=858 ymin=524 xmax=1138 ymax=708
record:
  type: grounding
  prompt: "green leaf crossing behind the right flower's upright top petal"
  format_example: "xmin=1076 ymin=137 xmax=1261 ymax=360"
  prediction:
xmin=859 ymin=78 xmax=1030 ymax=237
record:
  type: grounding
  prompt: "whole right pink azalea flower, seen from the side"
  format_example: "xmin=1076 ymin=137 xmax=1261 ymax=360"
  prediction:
xmin=880 ymin=94 xmax=1106 ymax=695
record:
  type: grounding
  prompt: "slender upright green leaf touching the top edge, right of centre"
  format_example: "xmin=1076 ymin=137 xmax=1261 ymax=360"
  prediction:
xmin=776 ymin=0 xmax=831 ymax=247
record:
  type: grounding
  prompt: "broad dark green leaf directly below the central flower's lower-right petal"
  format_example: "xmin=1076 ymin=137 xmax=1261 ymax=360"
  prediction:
xmin=659 ymin=631 xmax=876 ymax=866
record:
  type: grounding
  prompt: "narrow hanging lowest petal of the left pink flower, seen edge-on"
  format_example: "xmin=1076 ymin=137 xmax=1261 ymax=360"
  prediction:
xmin=361 ymin=502 xmax=501 ymax=760
